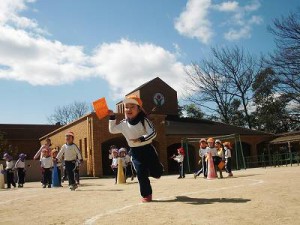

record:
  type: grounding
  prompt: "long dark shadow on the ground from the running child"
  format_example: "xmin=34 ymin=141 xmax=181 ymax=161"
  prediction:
xmin=153 ymin=196 xmax=251 ymax=205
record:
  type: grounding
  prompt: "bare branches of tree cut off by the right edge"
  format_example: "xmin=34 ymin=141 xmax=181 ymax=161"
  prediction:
xmin=267 ymin=8 xmax=300 ymax=105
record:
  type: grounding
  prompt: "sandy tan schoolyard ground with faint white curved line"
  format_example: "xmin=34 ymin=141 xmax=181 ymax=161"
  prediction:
xmin=0 ymin=166 xmax=300 ymax=225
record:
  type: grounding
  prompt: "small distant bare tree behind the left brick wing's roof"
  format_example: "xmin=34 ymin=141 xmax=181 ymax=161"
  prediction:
xmin=48 ymin=101 xmax=90 ymax=125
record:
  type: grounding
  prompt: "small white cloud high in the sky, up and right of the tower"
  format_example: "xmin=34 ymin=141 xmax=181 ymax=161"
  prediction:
xmin=175 ymin=0 xmax=213 ymax=44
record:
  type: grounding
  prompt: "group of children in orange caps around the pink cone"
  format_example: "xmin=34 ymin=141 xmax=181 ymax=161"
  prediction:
xmin=194 ymin=138 xmax=233 ymax=179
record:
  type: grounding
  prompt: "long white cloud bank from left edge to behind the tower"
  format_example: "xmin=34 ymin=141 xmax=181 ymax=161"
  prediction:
xmin=0 ymin=0 xmax=188 ymax=98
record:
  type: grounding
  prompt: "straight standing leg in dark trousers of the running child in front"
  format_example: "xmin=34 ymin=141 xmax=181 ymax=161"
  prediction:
xmin=132 ymin=158 xmax=152 ymax=197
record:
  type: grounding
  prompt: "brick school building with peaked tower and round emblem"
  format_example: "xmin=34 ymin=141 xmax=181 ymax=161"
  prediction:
xmin=40 ymin=77 xmax=273 ymax=177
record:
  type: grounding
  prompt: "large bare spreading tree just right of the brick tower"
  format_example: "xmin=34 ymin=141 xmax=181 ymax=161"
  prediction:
xmin=186 ymin=46 xmax=260 ymax=128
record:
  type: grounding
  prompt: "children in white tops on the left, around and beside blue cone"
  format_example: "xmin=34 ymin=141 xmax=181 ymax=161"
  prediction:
xmin=1 ymin=132 xmax=82 ymax=190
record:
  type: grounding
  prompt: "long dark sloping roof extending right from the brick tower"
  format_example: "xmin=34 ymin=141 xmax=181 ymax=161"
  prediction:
xmin=166 ymin=116 xmax=273 ymax=136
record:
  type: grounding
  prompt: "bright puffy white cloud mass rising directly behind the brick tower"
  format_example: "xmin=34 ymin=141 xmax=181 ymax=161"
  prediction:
xmin=92 ymin=39 xmax=185 ymax=98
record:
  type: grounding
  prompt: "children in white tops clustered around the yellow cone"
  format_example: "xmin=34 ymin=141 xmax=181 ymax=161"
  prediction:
xmin=109 ymin=145 xmax=135 ymax=184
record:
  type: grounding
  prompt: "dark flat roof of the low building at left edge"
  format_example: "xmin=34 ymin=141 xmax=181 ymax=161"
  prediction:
xmin=0 ymin=124 xmax=61 ymax=140
